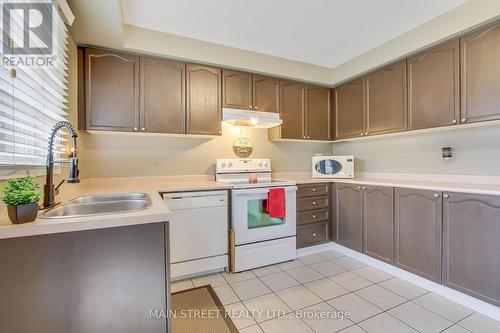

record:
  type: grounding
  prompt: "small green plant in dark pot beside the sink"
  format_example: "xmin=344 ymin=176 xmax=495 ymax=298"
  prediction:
xmin=2 ymin=176 xmax=41 ymax=224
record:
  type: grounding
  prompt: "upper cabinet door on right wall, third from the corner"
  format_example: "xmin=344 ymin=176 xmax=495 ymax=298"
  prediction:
xmin=408 ymin=39 xmax=460 ymax=129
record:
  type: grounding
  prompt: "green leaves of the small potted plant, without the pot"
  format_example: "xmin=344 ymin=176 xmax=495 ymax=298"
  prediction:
xmin=2 ymin=176 xmax=41 ymax=206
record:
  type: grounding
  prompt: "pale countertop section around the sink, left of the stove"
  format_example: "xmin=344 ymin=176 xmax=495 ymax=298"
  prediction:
xmin=0 ymin=176 xmax=231 ymax=239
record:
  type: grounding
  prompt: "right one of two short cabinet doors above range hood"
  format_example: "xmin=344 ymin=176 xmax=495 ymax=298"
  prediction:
xmin=253 ymin=75 xmax=280 ymax=112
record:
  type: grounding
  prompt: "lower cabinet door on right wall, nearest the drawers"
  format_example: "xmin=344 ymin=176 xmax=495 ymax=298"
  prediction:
xmin=335 ymin=184 xmax=363 ymax=252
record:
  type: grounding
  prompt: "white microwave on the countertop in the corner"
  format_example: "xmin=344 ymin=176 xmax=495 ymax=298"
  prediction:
xmin=312 ymin=155 xmax=354 ymax=178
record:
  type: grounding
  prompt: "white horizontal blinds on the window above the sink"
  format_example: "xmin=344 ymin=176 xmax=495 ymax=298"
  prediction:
xmin=0 ymin=0 xmax=68 ymax=166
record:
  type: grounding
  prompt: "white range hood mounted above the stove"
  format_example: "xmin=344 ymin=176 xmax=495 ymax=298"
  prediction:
xmin=222 ymin=108 xmax=283 ymax=128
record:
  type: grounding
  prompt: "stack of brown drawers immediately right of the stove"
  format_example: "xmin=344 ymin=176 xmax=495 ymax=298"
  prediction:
xmin=297 ymin=183 xmax=330 ymax=248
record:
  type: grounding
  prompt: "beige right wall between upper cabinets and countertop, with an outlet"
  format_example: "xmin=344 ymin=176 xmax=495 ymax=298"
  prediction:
xmin=333 ymin=125 xmax=500 ymax=176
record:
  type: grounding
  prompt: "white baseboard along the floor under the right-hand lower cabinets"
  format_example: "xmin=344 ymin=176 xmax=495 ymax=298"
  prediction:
xmin=297 ymin=242 xmax=500 ymax=320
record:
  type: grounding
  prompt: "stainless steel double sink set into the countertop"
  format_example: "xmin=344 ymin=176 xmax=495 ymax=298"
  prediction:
xmin=40 ymin=192 xmax=151 ymax=219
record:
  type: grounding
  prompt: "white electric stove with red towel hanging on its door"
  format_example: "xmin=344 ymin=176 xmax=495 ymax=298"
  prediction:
xmin=215 ymin=159 xmax=297 ymax=272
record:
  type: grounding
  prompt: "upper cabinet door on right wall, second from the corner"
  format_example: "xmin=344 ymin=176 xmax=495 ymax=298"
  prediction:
xmin=365 ymin=60 xmax=408 ymax=135
